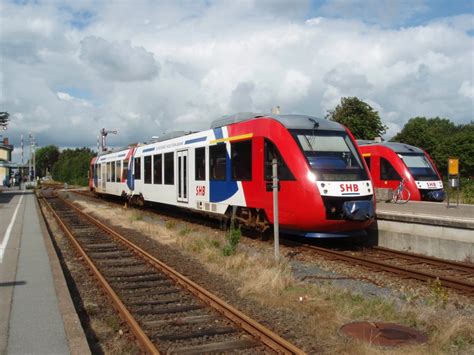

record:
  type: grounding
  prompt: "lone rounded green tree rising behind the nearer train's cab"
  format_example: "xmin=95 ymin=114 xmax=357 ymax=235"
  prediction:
xmin=326 ymin=97 xmax=388 ymax=139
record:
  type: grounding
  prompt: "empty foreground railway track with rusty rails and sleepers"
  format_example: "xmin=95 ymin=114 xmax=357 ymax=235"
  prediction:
xmin=39 ymin=196 xmax=303 ymax=354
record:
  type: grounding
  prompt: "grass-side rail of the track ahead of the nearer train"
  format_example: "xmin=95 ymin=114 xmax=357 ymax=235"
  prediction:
xmin=306 ymin=245 xmax=474 ymax=296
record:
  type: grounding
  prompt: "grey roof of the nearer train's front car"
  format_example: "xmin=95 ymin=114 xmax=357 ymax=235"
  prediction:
xmin=211 ymin=112 xmax=345 ymax=131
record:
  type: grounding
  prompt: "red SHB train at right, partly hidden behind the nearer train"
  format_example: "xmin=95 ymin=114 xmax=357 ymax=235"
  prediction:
xmin=357 ymin=140 xmax=445 ymax=202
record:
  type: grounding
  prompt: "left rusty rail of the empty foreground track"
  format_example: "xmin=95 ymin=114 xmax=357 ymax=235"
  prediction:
xmin=39 ymin=198 xmax=160 ymax=354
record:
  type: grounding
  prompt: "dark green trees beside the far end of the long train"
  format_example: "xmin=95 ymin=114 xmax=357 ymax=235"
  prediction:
xmin=52 ymin=148 xmax=95 ymax=186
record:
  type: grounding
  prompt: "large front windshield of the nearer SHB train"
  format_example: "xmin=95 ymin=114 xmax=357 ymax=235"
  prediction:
xmin=292 ymin=129 xmax=369 ymax=181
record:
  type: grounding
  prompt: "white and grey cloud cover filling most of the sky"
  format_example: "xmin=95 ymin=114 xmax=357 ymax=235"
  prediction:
xmin=0 ymin=0 xmax=474 ymax=159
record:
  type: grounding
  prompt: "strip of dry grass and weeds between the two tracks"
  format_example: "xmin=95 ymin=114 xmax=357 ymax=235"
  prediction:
xmin=71 ymin=201 xmax=474 ymax=354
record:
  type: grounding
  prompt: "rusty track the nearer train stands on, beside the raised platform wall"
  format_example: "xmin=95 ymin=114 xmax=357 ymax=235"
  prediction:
xmin=67 ymin=192 xmax=474 ymax=297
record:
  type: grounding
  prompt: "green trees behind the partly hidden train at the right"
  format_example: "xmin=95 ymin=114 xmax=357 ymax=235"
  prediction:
xmin=391 ymin=117 xmax=474 ymax=177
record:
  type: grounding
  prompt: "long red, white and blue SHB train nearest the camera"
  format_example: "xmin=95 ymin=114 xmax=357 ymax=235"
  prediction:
xmin=90 ymin=113 xmax=375 ymax=238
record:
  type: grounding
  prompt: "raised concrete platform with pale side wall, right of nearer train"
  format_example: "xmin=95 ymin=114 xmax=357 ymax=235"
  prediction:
xmin=369 ymin=201 xmax=474 ymax=263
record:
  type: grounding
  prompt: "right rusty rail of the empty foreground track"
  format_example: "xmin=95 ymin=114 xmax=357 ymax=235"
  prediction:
xmin=54 ymin=197 xmax=304 ymax=354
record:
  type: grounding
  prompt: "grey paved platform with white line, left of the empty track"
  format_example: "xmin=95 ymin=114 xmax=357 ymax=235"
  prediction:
xmin=0 ymin=188 xmax=90 ymax=354
